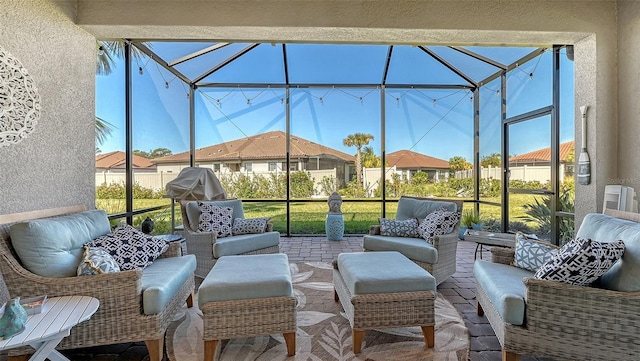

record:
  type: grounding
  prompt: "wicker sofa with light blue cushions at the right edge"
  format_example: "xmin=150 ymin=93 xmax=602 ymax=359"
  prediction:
xmin=474 ymin=210 xmax=640 ymax=361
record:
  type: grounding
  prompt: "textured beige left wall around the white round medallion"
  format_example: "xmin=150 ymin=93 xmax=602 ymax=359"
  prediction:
xmin=0 ymin=0 xmax=95 ymax=214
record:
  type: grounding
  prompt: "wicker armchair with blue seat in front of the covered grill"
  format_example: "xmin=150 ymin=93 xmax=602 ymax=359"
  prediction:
xmin=180 ymin=199 xmax=280 ymax=278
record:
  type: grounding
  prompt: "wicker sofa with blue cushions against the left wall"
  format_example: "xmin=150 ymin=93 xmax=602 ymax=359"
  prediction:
xmin=0 ymin=206 xmax=196 ymax=361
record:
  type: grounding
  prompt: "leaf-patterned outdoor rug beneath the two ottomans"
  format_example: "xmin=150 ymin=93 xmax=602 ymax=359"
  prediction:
xmin=165 ymin=262 xmax=469 ymax=361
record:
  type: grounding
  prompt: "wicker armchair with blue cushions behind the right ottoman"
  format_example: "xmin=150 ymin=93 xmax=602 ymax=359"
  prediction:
xmin=362 ymin=196 xmax=463 ymax=285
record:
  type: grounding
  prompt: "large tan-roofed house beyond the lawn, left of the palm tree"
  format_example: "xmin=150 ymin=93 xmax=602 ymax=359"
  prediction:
xmin=152 ymin=131 xmax=355 ymax=181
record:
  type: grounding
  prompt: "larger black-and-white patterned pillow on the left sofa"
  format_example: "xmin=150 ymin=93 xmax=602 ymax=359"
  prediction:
xmin=85 ymin=224 xmax=169 ymax=271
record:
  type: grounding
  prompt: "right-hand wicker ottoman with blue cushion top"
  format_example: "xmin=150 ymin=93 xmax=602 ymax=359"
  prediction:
xmin=333 ymin=252 xmax=436 ymax=353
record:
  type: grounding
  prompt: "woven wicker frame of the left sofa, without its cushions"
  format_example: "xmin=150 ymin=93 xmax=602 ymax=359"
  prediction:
xmin=0 ymin=206 xmax=194 ymax=361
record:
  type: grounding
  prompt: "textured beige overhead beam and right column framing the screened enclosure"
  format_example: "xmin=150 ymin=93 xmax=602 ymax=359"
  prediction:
xmin=78 ymin=0 xmax=620 ymax=224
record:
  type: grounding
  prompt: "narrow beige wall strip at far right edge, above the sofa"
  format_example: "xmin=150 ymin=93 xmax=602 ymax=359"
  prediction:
xmin=611 ymin=1 xmax=640 ymax=199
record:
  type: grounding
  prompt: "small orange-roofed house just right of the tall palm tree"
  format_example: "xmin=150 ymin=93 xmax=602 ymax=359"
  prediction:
xmin=386 ymin=150 xmax=449 ymax=180
